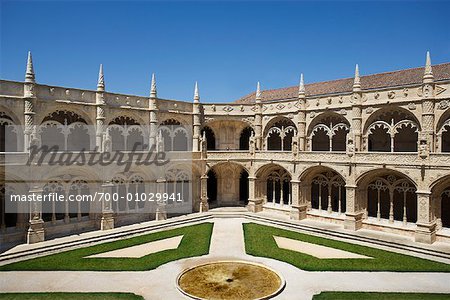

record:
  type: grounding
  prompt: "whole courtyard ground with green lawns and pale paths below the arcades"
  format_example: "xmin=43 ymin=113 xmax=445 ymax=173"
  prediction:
xmin=0 ymin=208 xmax=450 ymax=299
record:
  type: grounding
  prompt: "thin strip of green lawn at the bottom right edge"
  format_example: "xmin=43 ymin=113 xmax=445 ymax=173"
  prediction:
xmin=313 ymin=292 xmax=450 ymax=300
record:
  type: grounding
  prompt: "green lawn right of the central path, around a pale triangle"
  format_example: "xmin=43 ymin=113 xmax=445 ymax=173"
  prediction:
xmin=243 ymin=223 xmax=450 ymax=272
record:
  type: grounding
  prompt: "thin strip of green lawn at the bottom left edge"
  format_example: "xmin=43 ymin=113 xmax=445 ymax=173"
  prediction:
xmin=0 ymin=293 xmax=144 ymax=300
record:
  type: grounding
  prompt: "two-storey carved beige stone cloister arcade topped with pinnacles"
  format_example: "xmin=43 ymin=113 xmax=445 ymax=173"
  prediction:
xmin=0 ymin=53 xmax=450 ymax=244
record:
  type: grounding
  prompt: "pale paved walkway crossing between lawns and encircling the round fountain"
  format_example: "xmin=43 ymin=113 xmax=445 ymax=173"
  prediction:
xmin=0 ymin=218 xmax=450 ymax=299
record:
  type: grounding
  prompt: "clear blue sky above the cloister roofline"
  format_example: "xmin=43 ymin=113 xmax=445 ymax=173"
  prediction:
xmin=0 ymin=0 xmax=450 ymax=102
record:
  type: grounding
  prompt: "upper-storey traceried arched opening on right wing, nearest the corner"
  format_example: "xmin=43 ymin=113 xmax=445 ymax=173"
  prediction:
xmin=265 ymin=118 xmax=297 ymax=151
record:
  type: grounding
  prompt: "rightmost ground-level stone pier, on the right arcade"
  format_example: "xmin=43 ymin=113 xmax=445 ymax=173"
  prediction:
xmin=415 ymin=191 xmax=436 ymax=244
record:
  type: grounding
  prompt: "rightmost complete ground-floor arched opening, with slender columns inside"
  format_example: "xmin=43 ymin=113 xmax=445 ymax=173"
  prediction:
xmin=367 ymin=174 xmax=417 ymax=225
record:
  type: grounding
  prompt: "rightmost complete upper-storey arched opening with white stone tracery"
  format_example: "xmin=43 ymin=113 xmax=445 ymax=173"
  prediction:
xmin=364 ymin=107 xmax=420 ymax=152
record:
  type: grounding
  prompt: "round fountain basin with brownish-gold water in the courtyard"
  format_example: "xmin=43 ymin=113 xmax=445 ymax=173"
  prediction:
xmin=177 ymin=261 xmax=285 ymax=300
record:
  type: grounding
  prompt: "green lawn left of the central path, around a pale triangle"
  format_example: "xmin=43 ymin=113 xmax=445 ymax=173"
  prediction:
xmin=0 ymin=223 xmax=213 ymax=271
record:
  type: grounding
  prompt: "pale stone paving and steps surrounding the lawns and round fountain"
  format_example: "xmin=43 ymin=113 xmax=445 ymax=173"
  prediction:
xmin=0 ymin=208 xmax=450 ymax=299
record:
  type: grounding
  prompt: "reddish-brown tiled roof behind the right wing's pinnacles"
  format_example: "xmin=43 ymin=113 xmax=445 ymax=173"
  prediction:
xmin=236 ymin=63 xmax=450 ymax=103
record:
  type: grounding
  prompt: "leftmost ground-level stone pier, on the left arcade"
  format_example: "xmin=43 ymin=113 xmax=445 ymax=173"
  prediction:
xmin=27 ymin=186 xmax=45 ymax=244
